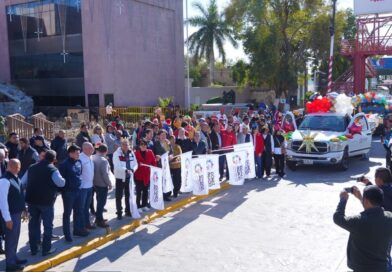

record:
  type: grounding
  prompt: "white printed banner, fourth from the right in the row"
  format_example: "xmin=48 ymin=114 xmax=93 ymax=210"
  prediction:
xmin=192 ymin=157 xmax=208 ymax=195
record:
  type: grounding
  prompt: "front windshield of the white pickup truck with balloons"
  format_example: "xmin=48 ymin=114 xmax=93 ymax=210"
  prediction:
xmin=299 ymin=115 xmax=349 ymax=132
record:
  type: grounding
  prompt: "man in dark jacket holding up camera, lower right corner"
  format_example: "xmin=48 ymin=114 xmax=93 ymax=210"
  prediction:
xmin=333 ymin=185 xmax=392 ymax=272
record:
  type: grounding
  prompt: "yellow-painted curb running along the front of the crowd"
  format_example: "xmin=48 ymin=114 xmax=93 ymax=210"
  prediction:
xmin=23 ymin=182 xmax=230 ymax=272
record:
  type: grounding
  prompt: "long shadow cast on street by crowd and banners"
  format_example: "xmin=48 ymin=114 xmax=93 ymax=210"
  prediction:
xmin=60 ymin=178 xmax=280 ymax=271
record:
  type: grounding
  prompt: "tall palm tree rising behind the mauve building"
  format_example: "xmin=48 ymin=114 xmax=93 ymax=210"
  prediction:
xmin=186 ymin=0 xmax=237 ymax=83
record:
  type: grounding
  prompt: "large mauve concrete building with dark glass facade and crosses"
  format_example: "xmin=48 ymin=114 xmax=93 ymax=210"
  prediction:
xmin=0 ymin=0 xmax=185 ymax=107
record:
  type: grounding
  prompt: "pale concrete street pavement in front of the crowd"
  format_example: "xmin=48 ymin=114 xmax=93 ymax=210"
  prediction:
xmin=0 ymin=139 xmax=385 ymax=272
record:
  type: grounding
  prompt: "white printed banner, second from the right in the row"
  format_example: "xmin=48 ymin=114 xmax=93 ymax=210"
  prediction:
xmin=226 ymin=151 xmax=246 ymax=185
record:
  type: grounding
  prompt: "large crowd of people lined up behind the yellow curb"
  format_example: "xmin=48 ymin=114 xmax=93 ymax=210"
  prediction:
xmin=0 ymin=107 xmax=298 ymax=271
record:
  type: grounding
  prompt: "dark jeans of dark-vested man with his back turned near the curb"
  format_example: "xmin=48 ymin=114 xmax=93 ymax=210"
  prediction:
xmin=29 ymin=204 xmax=54 ymax=253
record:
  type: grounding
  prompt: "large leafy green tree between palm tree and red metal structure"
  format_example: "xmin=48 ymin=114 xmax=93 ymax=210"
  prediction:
xmin=225 ymin=0 xmax=355 ymax=97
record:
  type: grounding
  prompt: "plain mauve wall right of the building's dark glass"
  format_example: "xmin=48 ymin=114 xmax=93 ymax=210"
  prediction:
xmin=82 ymin=0 xmax=185 ymax=106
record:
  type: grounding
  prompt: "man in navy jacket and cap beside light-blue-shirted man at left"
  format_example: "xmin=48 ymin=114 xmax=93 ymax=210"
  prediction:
xmin=59 ymin=145 xmax=88 ymax=242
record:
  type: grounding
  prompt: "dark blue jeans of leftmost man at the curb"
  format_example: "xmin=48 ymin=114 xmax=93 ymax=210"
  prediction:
xmin=5 ymin=213 xmax=22 ymax=267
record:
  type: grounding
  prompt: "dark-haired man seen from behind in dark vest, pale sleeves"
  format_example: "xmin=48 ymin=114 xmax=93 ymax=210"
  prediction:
xmin=22 ymin=150 xmax=65 ymax=256
